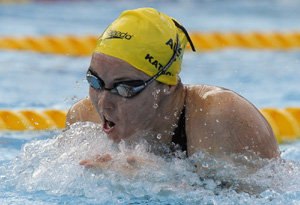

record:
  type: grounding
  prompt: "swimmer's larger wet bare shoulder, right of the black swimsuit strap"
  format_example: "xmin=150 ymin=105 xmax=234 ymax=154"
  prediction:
xmin=187 ymin=89 xmax=279 ymax=158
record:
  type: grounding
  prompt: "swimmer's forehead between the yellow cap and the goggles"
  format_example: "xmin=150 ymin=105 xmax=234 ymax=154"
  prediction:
xmin=91 ymin=52 xmax=149 ymax=80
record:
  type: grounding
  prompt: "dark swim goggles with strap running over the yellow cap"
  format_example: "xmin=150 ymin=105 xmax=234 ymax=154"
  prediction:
xmin=86 ymin=34 xmax=180 ymax=98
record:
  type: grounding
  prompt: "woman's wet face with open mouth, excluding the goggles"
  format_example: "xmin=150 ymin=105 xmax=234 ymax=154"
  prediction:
xmin=89 ymin=53 xmax=165 ymax=143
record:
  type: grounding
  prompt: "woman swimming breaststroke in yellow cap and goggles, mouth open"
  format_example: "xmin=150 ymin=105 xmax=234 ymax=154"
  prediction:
xmin=66 ymin=8 xmax=280 ymax=167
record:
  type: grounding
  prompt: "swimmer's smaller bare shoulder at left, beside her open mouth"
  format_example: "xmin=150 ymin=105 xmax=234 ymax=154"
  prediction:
xmin=66 ymin=97 xmax=101 ymax=128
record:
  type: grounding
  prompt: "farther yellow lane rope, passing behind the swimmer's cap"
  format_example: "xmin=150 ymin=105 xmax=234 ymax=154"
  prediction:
xmin=0 ymin=32 xmax=300 ymax=56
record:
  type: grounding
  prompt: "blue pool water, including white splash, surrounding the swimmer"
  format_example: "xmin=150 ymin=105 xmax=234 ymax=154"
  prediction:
xmin=0 ymin=0 xmax=300 ymax=204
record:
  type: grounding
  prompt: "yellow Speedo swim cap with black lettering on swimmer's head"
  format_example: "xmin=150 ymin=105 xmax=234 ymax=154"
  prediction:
xmin=94 ymin=8 xmax=188 ymax=85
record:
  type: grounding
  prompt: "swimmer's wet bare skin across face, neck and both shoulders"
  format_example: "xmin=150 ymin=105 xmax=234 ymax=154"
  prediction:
xmin=67 ymin=53 xmax=280 ymax=167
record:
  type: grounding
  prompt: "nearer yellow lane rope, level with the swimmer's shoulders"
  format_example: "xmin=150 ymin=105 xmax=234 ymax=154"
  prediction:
xmin=0 ymin=107 xmax=300 ymax=143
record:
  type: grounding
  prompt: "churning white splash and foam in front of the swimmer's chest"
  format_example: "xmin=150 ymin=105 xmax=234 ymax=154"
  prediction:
xmin=0 ymin=123 xmax=300 ymax=204
